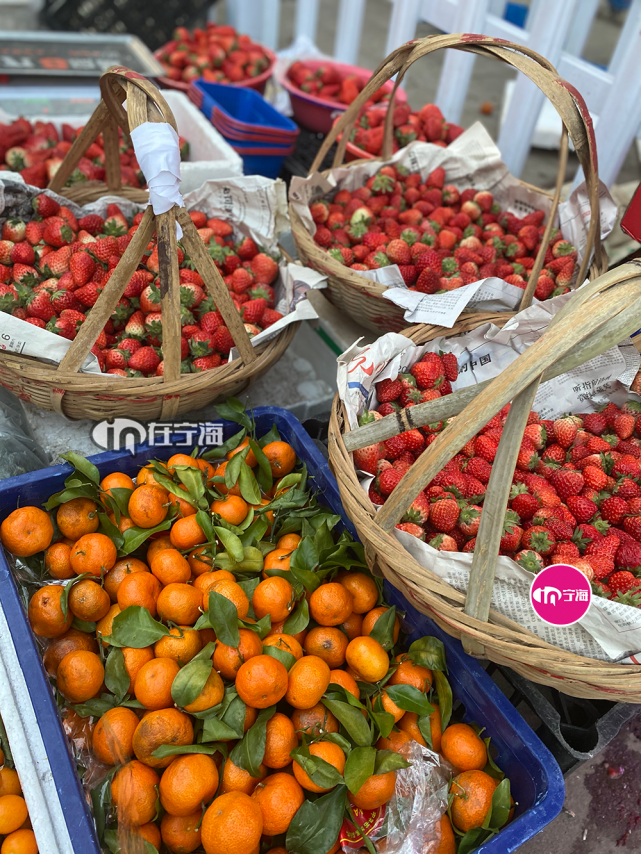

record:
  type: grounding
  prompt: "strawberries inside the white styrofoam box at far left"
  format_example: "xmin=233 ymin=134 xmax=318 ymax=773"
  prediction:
xmin=0 ymin=118 xmax=189 ymax=189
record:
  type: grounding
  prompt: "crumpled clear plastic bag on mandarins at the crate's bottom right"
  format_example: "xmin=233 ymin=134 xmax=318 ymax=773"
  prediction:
xmin=376 ymin=741 xmax=452 ymax=854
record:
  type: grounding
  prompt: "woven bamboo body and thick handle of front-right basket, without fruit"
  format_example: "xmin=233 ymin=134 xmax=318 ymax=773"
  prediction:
xmin=329 ymin=262 xmax=641 ymax=703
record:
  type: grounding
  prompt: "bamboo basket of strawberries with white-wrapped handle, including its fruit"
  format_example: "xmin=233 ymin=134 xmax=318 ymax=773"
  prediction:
xmin=0 ymin=70 xmax=296 ymax=419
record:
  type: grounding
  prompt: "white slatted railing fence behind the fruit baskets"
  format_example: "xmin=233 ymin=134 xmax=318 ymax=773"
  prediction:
xmin=222 ymin=0 xmax=641 ymax=185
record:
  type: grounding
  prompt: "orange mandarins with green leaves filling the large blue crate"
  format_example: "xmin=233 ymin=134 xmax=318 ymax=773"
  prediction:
xmin=0 ymin=400 xmax=562 ymax=854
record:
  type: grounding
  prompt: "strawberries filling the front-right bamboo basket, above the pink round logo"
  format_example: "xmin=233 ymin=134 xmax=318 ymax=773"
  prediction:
xmin=354 ymin=353 xmax=641 ymax=607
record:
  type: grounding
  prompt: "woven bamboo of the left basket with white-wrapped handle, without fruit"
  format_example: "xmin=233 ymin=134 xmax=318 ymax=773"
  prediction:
xmin=0 ymin=67 xmax=299 ymax=421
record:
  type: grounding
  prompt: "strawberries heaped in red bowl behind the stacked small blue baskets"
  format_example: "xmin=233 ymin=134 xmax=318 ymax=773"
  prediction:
xmin=156 ymin=23 xmax=270 ymax=83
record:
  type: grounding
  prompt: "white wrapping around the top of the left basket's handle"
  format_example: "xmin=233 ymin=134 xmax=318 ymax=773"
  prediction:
xmin=131 ymin=122 xmax=183 ymax=239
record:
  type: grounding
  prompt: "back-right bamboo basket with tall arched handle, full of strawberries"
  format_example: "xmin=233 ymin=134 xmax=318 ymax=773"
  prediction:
xmin=290 ymin=36 xmax=607 ymax=334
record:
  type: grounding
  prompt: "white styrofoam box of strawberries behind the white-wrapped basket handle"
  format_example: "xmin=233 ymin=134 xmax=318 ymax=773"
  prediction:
xmin=0 ymin=86 xmax=243 ymax=194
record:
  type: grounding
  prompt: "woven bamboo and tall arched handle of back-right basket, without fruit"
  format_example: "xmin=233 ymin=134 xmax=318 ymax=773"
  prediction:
xmin=290 ymin=33 xmax=607 ymax=334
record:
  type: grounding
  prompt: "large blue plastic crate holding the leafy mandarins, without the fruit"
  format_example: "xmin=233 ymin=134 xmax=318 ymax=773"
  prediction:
xmin=0 ymin=406 xmax=565 ymax=854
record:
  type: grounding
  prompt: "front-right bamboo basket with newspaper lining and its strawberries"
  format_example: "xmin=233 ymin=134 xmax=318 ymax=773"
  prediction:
xmin=329 ymin=265 xmax=641 ymax=702
